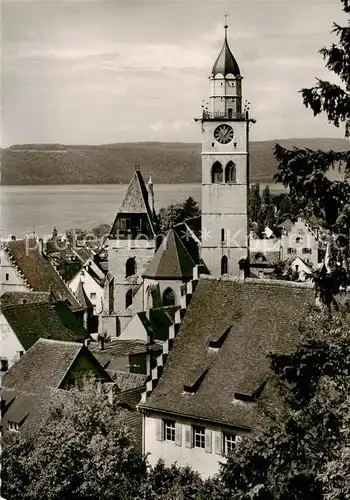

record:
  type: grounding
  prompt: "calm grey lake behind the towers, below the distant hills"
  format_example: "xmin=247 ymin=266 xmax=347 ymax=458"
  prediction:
xmin=1 ymin=184 xmax=283 ymax=238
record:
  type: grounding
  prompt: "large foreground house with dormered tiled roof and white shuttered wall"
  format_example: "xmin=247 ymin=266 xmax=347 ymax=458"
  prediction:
xmin=139 ymin=276 xmax=314 ymax=477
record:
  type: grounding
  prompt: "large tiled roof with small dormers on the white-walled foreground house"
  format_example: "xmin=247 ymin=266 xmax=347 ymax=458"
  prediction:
xmin=140 ymin=277 xmax=314 ymax=428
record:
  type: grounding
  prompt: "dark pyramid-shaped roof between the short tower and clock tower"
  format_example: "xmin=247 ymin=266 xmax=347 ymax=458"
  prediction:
xmin=142 ymin=229 xmax=195 ymax=279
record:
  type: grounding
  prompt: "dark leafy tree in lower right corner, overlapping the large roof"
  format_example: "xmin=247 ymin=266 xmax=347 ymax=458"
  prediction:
xmin=220 ymin=314 xmax=350 ymax=500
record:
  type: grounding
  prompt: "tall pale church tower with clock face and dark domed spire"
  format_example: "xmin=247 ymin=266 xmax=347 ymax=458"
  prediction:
xmin=200 ymin=25 xmax=249 ymax=276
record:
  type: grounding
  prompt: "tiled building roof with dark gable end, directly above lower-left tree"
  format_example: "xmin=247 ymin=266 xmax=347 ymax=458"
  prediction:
xmin=1 ymin=339 xmax=111 ymax=435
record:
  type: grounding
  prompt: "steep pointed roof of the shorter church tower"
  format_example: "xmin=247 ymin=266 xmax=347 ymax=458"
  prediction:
xmin=110 ymin=170 xmax=156 ymax=234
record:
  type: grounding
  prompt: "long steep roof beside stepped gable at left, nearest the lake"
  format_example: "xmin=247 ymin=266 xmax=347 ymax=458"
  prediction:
xmin=6 ymin=239 xmax=83 ymax=311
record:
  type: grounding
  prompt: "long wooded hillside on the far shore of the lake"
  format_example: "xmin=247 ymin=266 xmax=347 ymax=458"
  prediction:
xmin=1 ymin=139 xmax=350 ymax=185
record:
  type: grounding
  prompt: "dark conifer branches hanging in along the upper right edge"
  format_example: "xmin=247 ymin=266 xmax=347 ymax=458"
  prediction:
xmin=274 ymin=0 xmax=350 ymax=234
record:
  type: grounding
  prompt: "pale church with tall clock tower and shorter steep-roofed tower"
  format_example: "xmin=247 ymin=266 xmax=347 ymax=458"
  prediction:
xmin=102 ymin=22 xmax=250 ymax=337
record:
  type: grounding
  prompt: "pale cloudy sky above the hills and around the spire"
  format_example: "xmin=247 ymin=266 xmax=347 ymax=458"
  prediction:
xmin=2 ymin=0 xmax=345 ymax=147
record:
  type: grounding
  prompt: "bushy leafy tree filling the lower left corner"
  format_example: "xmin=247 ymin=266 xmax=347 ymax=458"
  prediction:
xmin=2 ymin=382 xmax=146 ymax=500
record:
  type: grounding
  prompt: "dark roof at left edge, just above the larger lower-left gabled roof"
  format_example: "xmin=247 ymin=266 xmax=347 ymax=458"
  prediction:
xmin=1 ymin=298 xmax=89 ymax=350
